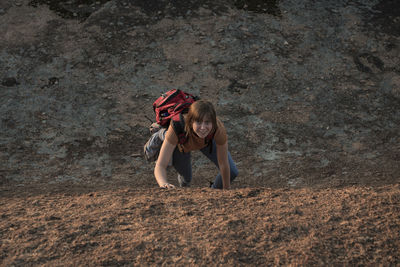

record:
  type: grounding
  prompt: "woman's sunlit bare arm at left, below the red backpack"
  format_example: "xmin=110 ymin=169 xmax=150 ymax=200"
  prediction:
xmin=154 ymin=139 xmax=176 ymax=188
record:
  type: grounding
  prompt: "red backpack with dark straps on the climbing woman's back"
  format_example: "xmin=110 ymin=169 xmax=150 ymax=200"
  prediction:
xmin=153 ymin=89 xmax=215 ymax=151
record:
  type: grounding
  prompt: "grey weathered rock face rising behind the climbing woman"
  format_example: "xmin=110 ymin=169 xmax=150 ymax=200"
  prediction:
xmin=0 ymin=0 xmax=400 ymax=187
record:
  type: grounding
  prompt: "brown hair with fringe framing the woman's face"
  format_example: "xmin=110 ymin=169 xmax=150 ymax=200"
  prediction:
xmin=185 ymin=100 xmax=217 ymax=138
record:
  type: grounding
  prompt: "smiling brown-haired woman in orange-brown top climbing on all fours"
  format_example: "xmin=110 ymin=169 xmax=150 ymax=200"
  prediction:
xmin=154 ymin=100 xmax=238 ymax=189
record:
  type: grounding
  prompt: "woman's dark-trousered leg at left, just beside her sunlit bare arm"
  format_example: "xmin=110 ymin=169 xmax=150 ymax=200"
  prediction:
xmin=172 ymin=147 xmax=192 ymax=187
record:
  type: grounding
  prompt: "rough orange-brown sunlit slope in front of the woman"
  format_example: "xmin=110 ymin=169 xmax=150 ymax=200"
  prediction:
xmin=0 ymin=185 xmax=400 ymax=266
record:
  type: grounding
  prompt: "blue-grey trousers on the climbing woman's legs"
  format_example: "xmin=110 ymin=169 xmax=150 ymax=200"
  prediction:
xmin=172 ymin=140 xmax=238 ymax=189
